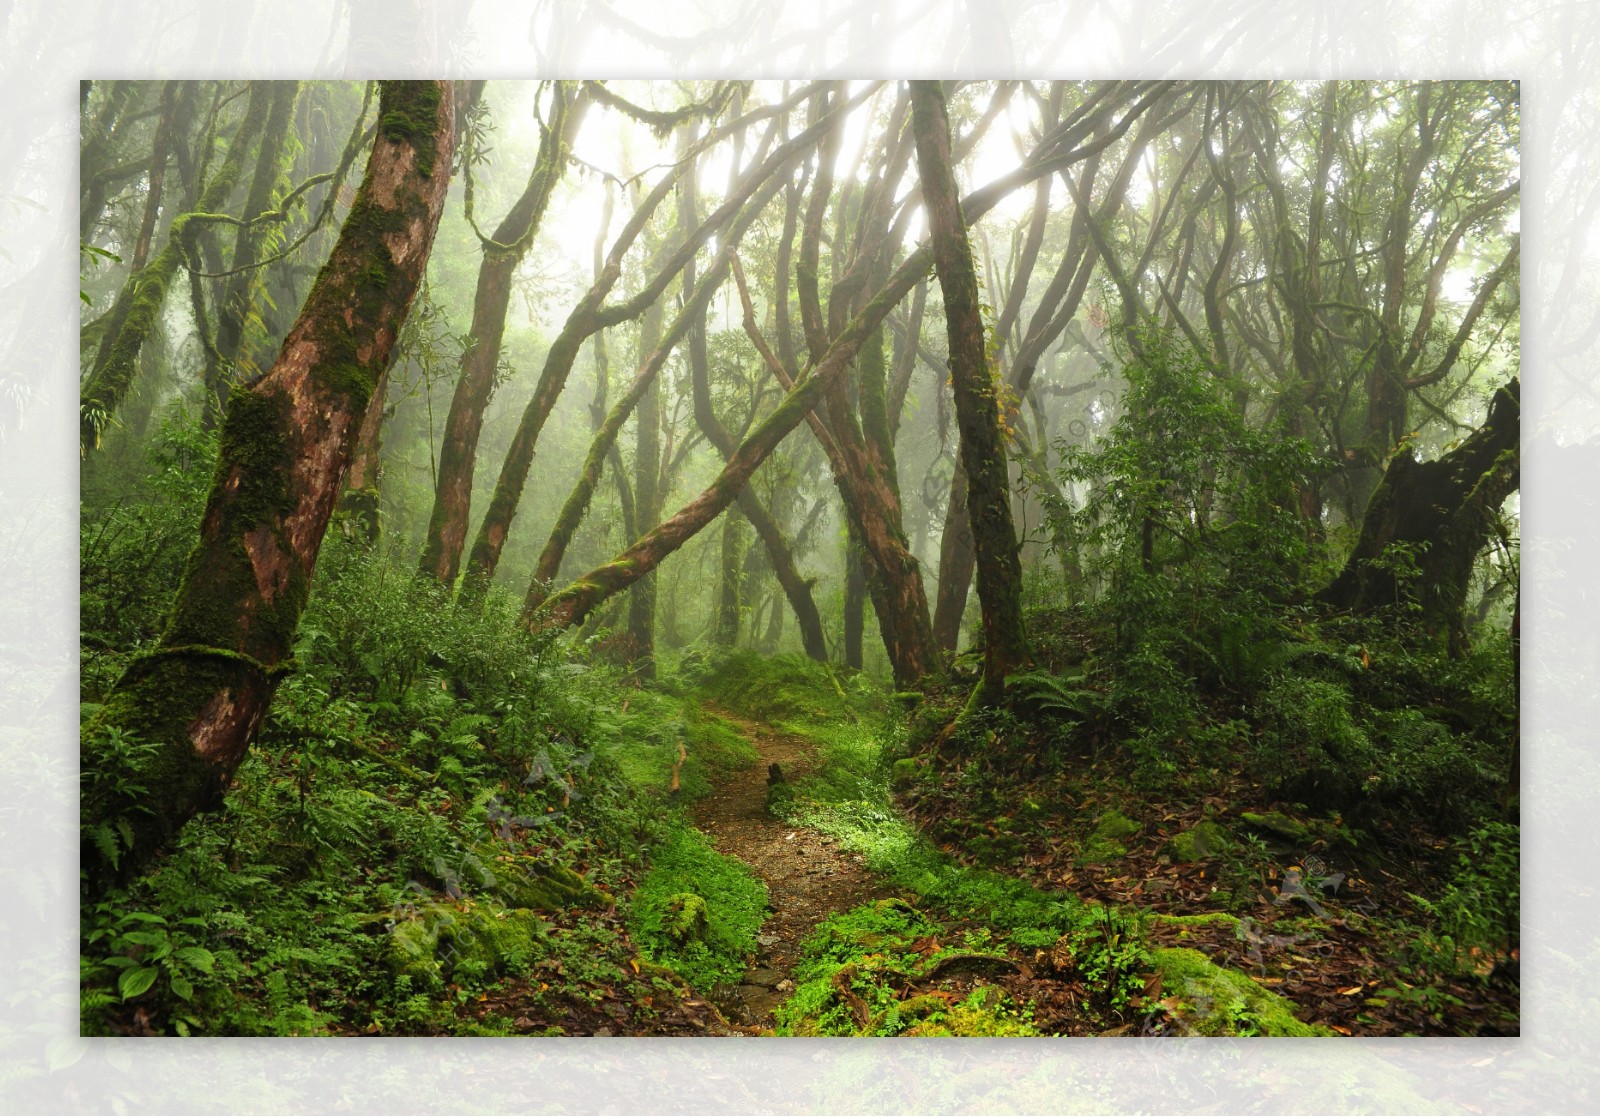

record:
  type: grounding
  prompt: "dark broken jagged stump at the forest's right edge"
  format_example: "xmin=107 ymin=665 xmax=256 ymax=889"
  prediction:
xmin=1318 ymin=379 xmax=1522 ymax=655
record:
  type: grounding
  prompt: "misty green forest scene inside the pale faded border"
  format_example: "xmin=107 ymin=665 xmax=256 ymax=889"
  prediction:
xmin=78 ymin=80 xmax=1522 ymax=1039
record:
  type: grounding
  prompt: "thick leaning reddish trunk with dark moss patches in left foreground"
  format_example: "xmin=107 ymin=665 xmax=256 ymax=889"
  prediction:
xmin=82 ymin=82 xmax=456 ymax=890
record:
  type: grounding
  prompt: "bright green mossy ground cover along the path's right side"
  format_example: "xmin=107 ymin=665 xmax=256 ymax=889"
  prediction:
xmin=736 ymin=675 xmax=1322 ymax=1035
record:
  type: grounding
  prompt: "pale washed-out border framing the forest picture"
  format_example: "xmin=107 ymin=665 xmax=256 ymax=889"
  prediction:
xmin=0 ymin=0 xmax=1600 ymax=1114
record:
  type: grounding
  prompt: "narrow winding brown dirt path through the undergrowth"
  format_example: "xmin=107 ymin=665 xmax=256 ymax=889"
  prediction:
xmin=694 ymin=711 xmax=893 ymax=1029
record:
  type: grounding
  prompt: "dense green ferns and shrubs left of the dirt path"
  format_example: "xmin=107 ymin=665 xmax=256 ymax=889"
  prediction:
xmin=80 ymin=528 xmax=765 ymax=1035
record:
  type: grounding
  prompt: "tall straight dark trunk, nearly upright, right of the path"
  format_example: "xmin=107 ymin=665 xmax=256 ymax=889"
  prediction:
xmin=912 ymin=82 xmax=1027 ymax=701
